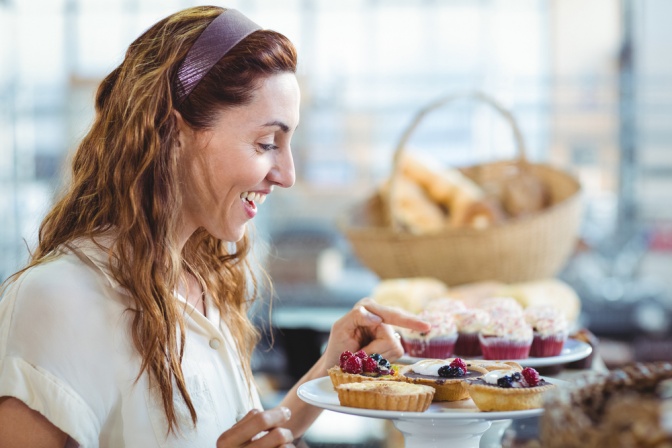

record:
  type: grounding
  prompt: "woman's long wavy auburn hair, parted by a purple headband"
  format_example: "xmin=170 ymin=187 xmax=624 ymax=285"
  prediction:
xmin=21 ymin=6 xmax=297 ymax=432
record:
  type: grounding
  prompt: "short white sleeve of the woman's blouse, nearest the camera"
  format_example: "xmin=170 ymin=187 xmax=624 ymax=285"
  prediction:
xmin=0 ymin=257 xmax=121 ymax=447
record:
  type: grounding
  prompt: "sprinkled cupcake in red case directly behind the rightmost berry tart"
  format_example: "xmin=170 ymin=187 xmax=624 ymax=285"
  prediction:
xmin=478 ymin=315 xmax=533 ymax=360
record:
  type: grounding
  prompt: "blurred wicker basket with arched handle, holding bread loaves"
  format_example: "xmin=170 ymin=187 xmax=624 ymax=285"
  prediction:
xmin=340 ymin=92 xmax=581 ymax=286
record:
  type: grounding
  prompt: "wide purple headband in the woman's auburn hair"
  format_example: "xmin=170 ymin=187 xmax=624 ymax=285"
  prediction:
xmin=175 ymin=9 xmax=261 ymax=104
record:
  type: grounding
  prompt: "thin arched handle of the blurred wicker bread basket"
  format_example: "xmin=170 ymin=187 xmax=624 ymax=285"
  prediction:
xmin=382 ymin=91 xmax=527 ymax=230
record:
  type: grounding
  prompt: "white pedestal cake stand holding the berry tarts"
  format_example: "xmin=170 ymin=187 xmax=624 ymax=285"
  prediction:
xmin=297 ymin=377 xmax=564 ymax=448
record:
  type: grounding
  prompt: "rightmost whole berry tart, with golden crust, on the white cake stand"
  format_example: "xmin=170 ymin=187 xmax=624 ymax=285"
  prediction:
xmin=466 ymin=367 xmax=556 ymax=412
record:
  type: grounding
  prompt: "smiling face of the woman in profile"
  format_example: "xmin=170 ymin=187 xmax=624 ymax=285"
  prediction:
xmin=178 ymin=73 xmax=300 ymax=243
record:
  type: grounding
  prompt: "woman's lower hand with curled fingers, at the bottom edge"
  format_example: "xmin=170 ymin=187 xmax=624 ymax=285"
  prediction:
xmin=217 ymin=406 xmax=294 ymax=448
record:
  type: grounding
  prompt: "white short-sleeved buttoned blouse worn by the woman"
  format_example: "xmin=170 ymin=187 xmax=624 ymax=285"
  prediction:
xmin=0 ymin=236 xmax=261 ymax=448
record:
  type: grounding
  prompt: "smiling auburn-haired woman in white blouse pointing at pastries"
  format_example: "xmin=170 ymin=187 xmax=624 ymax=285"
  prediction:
xmin=0 ymin=7 xmax=428 ymax=448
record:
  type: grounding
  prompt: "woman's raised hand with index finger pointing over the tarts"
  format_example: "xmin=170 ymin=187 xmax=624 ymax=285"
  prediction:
xmin=324 ymin=298 xmax=431 ymax=368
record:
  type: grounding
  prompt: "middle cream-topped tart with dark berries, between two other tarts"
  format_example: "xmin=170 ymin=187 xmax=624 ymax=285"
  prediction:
xmin=399 ymin=358 xmax=488 ymax=401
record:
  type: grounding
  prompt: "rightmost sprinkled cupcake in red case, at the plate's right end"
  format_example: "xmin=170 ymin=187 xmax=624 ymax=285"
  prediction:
xmin=524 ymin=306 xmax=568 ymax=358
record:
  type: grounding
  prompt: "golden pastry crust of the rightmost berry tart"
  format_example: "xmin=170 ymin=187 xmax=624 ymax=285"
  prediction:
xmin=466 ymin=382 xmax=555 ymax=412
